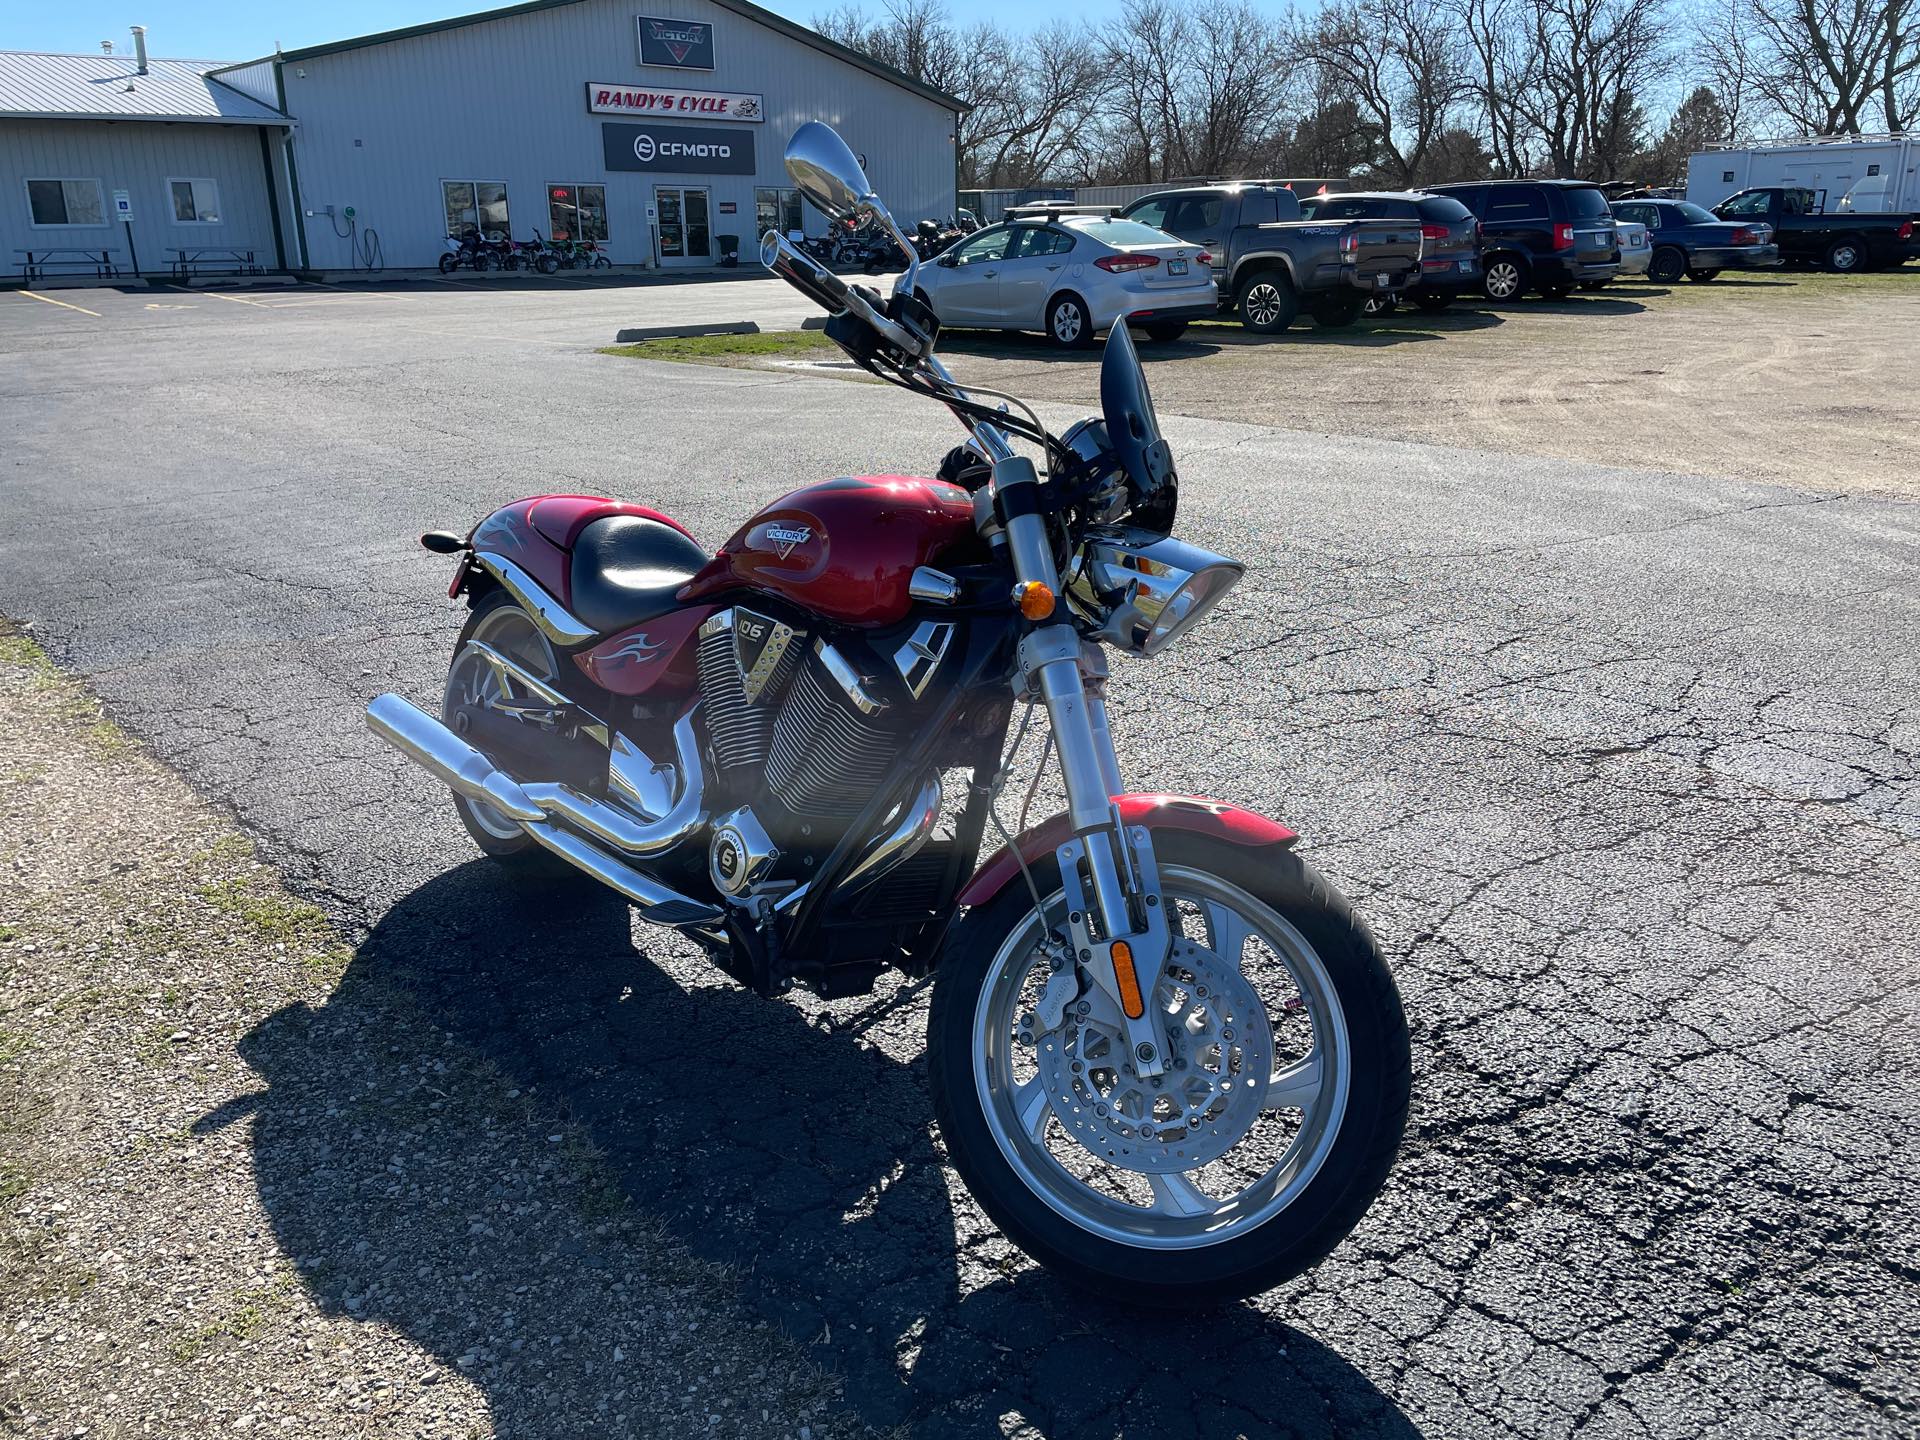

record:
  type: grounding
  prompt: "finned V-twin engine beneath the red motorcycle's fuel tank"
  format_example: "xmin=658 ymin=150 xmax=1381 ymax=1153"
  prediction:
xmin=697 ymin=607 xmax=925 ymax=875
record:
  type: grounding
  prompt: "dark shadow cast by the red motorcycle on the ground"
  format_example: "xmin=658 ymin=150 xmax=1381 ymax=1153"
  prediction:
xmin=220 ymin=860 xmax=1419 ymax=1440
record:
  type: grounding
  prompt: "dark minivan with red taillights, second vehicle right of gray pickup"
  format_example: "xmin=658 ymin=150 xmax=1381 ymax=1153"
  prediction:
xmin=1432 ymin=180 xmax=1620 ymax=300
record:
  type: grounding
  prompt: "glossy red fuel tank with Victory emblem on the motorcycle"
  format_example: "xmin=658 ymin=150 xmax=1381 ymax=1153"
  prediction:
xmin=680 ymin=474 xmax=975 ymax=626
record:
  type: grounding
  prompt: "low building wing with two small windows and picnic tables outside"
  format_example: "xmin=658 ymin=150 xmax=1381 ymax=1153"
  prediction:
xmin=0 ymin=33 xmax=288 ymax=276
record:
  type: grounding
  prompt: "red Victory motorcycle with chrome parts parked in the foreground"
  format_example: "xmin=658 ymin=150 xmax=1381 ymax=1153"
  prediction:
xmin=367 ymin=123 xmax=1409 ymax=1306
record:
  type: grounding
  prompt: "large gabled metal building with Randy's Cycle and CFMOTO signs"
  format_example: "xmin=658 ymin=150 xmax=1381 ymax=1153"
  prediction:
xmin=215 ymin=0 xmax=960 ymax=271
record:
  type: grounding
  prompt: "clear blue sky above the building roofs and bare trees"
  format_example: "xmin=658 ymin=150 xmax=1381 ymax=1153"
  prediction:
xmin=0 ymin=0 xmax=1119 ymax=60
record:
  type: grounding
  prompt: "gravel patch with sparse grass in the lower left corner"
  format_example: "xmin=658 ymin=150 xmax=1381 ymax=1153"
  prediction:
xmin=0 ymin=622 xmax=864 ymax=1440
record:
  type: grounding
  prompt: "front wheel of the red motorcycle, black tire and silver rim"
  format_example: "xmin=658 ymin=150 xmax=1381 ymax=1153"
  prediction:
xmin=927 ymin=831 xmax=1411 ymax=1309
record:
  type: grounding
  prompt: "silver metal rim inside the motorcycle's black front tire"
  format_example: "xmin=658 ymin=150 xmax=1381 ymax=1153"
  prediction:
xmin=973 ymin=866 xmax=1352 ymax=1250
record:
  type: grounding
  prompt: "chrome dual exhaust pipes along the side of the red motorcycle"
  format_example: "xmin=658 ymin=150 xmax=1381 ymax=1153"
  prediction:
xmin=367 ymin=695 xmax=722 ymax=925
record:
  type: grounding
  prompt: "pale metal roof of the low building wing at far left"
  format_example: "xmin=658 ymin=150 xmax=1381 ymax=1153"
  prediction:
xmin=0 ymin=50 xmax=288 ymax=125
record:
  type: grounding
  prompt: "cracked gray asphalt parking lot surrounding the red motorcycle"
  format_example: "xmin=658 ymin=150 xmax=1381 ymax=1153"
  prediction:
xmin=0 ymin=275 xmax=1920 ymax=1440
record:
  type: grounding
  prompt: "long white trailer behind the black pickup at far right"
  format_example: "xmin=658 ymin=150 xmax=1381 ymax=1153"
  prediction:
xmin=1686 ymin=132 xmax=1920 ymax=215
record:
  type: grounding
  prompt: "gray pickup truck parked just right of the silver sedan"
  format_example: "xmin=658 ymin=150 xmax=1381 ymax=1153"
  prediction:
xmin=1121 ymin=180 xmax=1421 ymax=334
